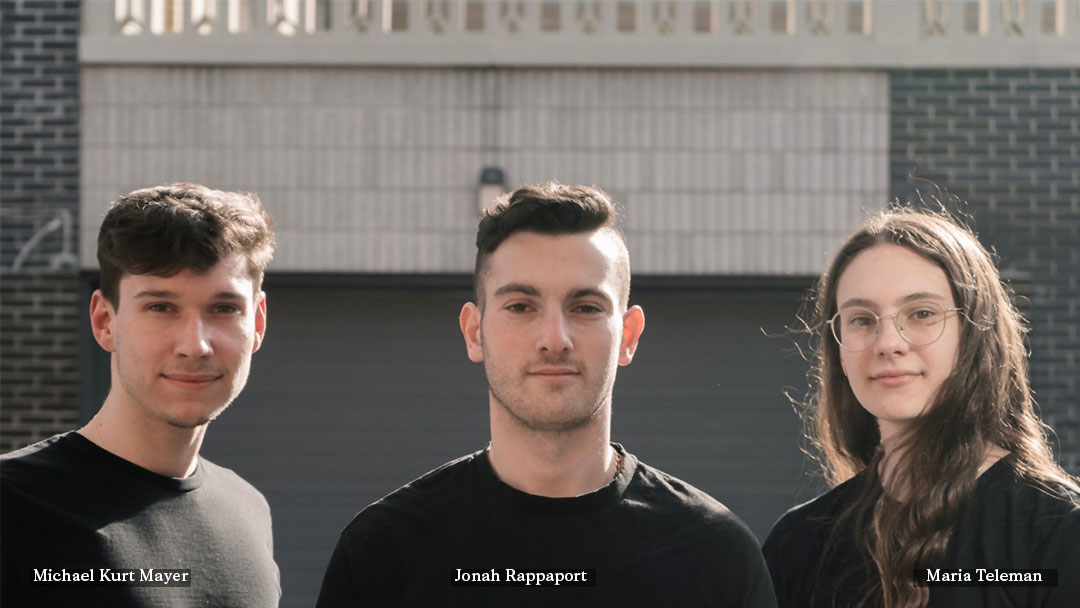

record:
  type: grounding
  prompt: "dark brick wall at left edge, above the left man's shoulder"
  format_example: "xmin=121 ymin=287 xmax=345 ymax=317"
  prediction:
xmin=0 ymin=0 xmax=80 ymax=451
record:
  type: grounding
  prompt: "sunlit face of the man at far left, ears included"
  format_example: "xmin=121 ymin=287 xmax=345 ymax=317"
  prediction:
xmin=92 ymin=255 xmax=266 ymax=428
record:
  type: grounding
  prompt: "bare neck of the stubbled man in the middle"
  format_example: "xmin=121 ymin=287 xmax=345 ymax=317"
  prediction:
xmin=488 ymin=398 xmax=618 ymax=498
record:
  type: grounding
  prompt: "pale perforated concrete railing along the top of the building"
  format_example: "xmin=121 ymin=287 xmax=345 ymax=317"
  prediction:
xmin=81 ymin=0 xmax=1080 ymax=67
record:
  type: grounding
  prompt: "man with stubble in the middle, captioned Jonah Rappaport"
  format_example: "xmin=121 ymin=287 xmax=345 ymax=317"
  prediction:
xmin=319 ymin=184 xmax=775 ymax=608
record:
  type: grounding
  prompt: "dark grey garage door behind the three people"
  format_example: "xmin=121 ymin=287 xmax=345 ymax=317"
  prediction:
xmin=196 ymin=278 xmax=814 ymax=607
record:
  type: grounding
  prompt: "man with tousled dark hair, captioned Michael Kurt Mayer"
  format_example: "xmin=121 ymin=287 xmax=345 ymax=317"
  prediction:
xmin=0 ymin=184 xmax=281 ymax=607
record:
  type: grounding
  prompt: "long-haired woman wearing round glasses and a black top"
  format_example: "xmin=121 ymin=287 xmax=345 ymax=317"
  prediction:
xmin=765 ymin=208 xmax=1080 ymax=608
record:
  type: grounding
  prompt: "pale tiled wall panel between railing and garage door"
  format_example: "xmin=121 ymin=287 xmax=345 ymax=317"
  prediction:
xmin=81 ymin=66 xmax=889 ymax=274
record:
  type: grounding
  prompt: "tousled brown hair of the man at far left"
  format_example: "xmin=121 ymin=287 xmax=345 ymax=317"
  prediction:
xmin=97 ymin=184 xmax=274 ymax=307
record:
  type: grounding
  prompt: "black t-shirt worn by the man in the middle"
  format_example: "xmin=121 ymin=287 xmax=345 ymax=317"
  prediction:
xmin=318 ymin=445 xmax=775 ymax=608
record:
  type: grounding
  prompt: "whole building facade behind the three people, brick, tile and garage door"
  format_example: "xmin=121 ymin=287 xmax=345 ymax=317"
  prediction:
xmin=0 ymin=0 xmax=1080 ymax=606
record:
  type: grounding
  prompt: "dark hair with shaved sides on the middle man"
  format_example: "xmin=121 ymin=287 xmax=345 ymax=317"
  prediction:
xmin=473 ymin=181 xmax=630 ymax=310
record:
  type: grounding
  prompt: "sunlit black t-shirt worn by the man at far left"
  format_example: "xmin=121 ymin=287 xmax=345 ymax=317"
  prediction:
xmin=0 ymin=432 xmax=281 ymax=608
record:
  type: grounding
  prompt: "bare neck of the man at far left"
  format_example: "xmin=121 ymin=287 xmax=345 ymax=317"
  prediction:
xmin=78 ymin=390 xmax=206 ymax=477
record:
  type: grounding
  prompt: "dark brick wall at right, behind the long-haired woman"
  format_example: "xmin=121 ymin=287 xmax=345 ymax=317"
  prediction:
xmin=890 ymin=69 xmax=1080 ymax=473
